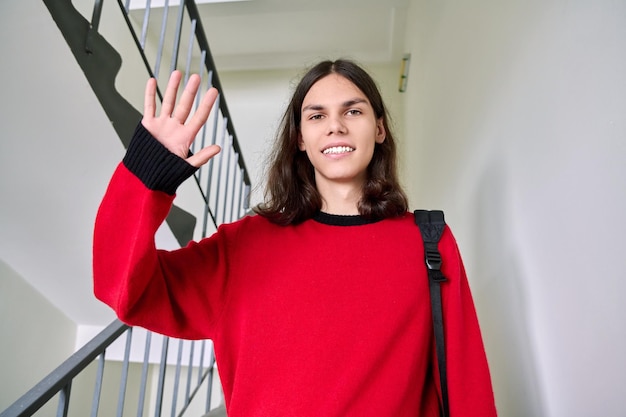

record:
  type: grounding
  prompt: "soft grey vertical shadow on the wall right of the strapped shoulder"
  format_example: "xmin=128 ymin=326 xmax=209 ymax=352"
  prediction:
xmin=472 ymin=158 xmax=546 ymax=417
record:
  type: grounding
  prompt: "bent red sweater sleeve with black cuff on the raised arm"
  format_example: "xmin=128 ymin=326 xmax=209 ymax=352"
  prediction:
xmin=93 ymin=125 xmax=227 ymax=339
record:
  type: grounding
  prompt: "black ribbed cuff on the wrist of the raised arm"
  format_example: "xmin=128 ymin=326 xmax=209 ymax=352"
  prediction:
xmin=123 ymin=123 xmax=197 ymax=195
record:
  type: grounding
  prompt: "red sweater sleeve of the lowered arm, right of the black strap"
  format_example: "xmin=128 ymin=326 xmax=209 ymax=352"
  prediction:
xmin=433 ymin=227 xmax=497 ymax=417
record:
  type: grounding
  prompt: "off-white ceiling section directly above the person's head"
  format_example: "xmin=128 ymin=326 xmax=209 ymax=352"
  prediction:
xmin=131 ymin=0 xmax=409 ymax=71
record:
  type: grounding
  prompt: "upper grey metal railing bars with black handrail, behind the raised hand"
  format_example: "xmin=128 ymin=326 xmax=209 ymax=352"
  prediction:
xmin=119 ymin=0 xmax=250 ymax=236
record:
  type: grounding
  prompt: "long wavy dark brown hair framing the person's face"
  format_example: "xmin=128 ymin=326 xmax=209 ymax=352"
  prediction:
xmin=254 ymin=59 xmax=408 ymax=225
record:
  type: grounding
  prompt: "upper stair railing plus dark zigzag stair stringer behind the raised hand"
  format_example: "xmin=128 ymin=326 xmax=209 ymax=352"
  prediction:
xmin=43 ymin=0 xmax=251 ymax=246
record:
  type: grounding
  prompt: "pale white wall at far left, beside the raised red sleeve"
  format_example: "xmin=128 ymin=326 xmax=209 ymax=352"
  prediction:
xmin=0 ymin=1 xmax=124 ymax=325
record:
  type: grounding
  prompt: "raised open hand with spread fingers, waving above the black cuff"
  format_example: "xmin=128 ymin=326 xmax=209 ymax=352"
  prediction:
xmin=141 ymin=71 xmax=220 ymax=167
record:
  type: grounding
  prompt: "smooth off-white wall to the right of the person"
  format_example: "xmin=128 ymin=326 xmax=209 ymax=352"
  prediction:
xmin=406 ymin=0 xmax=626 ymax=417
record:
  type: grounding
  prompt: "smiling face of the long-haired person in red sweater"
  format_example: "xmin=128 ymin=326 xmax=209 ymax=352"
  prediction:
xmin=298 ymin=74 xmax=386 ymax=192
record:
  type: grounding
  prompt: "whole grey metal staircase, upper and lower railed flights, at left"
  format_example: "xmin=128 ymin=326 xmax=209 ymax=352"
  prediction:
xmin=0 ymin=0 xmax=250 ymax=417
